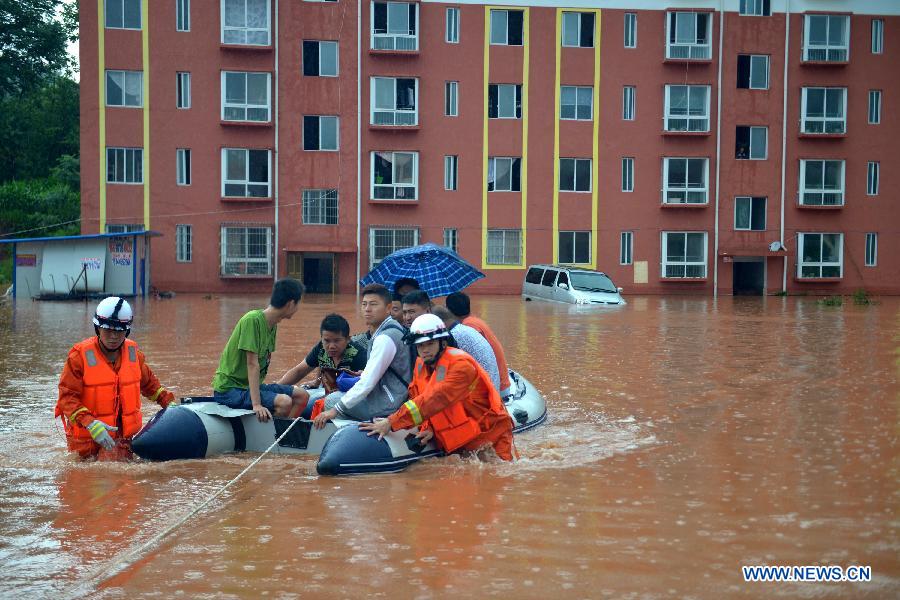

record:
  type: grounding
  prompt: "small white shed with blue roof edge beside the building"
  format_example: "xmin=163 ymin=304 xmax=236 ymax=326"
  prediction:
xmin=0 ymin=231 xmax=161 ymax=300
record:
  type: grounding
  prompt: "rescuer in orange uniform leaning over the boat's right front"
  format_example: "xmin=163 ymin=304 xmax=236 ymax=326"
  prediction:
xmin=359 ymin=314 xmax=515 ymax=460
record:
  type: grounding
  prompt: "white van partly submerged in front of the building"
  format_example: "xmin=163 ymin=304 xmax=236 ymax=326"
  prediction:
xmin=522 ymin=265 xmax=625 ymax=305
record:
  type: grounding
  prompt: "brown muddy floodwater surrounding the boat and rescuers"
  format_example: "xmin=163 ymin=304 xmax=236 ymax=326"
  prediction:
xmin=0 ymin=296 xmax=900 ymax=598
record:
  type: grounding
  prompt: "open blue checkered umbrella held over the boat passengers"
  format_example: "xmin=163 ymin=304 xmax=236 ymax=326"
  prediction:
xmin=359 ymin=244 xmax=484 ymax=298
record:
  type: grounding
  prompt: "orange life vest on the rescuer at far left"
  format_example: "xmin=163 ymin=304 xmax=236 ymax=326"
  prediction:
xmin=65 ymin=337 xmax=143 ymax=440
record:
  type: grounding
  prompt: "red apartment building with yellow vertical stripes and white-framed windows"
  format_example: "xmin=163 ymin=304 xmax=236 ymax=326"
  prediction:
xmin=80 ymin=0 xmax=900 ymax=294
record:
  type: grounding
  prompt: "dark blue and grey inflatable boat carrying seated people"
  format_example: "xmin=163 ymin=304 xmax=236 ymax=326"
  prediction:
xmin=132 ymin=371 xmax=547 ymax=475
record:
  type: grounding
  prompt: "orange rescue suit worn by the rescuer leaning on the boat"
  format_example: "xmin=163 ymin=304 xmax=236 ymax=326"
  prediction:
xmin=388 ymin=348 xmax=515 ymax=460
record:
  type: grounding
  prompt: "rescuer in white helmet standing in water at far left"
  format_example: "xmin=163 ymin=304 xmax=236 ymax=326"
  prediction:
xmin=55 ymin=296 xmax=175 ymax=460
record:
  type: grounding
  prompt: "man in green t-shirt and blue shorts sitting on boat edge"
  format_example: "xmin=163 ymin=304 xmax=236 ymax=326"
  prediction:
xmin=212 ymin=278 xmax=306 ymax=422
